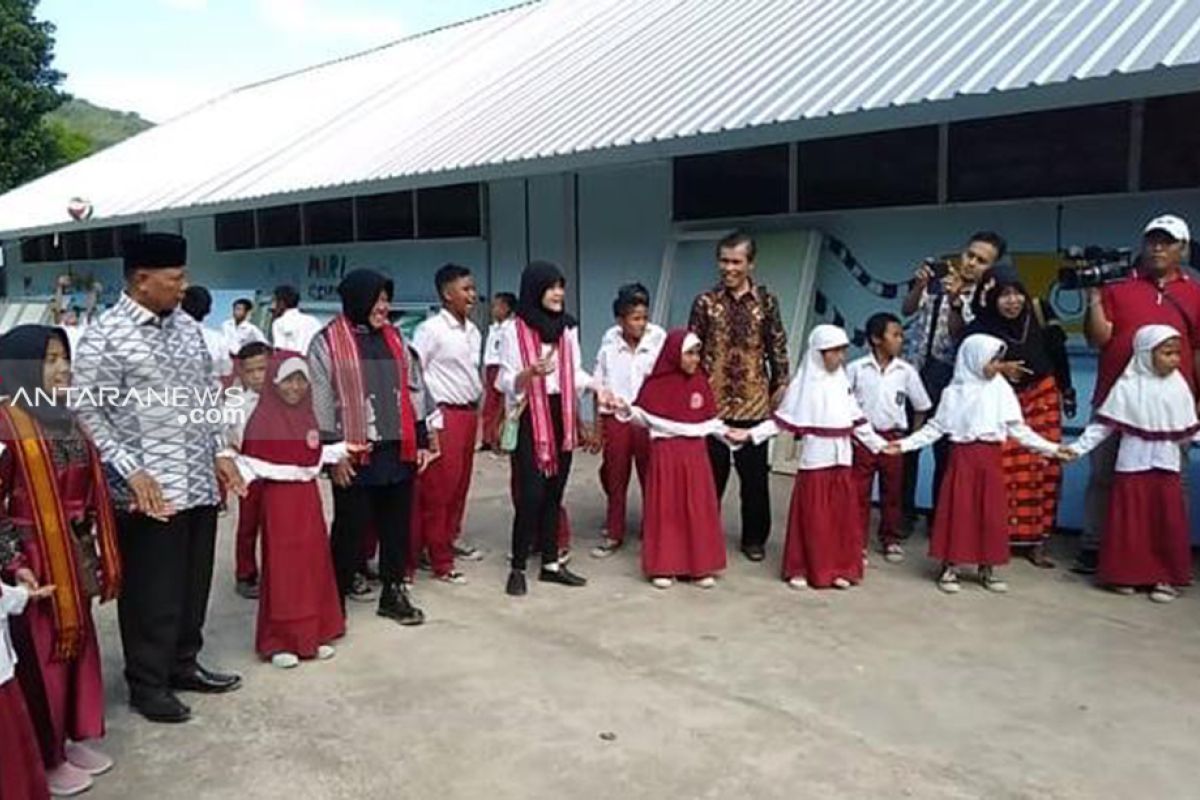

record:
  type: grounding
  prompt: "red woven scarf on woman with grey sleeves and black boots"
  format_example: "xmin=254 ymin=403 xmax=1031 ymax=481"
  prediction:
xmin=324 ymin=314 xmax=416 ymax=463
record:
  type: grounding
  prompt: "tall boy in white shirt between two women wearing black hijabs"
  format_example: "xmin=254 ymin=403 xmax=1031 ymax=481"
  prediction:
xmin=413 ymin=264 xmax=484 ymax=584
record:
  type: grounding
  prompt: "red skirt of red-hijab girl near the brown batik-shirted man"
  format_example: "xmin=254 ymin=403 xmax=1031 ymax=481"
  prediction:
xmin=642 ymin=438 xmax=725 ymax=578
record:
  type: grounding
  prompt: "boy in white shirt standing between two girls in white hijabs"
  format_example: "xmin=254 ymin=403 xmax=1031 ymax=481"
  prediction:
xmin=846 ymin=313 xmax=932 ymax=564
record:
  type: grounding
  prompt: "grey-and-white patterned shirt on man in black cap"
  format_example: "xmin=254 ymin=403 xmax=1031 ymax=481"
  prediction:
xmin=71 ymin=294 xmax=225 ymax=511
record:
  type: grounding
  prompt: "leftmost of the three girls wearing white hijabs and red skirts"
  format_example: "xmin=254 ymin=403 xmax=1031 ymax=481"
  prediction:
xmin=749 ymin=325 xmax=887 ymax=589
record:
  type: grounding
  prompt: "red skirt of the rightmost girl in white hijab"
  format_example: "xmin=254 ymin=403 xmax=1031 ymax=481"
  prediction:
xmin=1098 ymin=469 xmax=1192 ymax=587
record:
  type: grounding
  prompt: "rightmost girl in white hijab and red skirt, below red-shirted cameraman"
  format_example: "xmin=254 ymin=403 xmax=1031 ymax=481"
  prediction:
xmin=1070 ymin=325 xmax=1200 ymax=603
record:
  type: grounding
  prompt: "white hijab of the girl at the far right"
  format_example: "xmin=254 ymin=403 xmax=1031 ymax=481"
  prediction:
xmin=1096 ymin=325 xmax=1198 ymax=439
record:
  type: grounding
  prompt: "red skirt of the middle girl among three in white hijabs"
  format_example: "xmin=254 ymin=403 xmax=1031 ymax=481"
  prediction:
xmin=929 ymin=441 xmax=1008 ymax=566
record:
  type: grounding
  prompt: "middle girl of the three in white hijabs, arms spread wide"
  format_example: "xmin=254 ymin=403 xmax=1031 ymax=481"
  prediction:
xmin=889 ymin=333 xmax=1066 ymax=594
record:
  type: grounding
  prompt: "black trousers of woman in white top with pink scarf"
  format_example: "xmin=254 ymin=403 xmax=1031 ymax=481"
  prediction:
xmin=512 ymin=395 xmax=571 ymax=570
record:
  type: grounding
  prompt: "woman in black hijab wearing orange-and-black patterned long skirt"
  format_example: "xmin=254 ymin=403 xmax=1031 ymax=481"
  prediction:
xmin=966 ymin=265 xmax=1075 ymax=569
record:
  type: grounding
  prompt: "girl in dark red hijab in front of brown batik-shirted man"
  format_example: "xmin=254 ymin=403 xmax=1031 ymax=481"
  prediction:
xmin=617 ymin=329 xmax=728 ymax=589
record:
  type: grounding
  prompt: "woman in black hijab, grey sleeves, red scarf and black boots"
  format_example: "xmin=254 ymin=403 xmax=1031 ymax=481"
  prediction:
xmin=308 ymin=270 xmax=434 ymax=625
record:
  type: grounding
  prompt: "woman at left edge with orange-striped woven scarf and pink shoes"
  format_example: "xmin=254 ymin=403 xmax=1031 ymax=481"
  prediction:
xmin=0 ymin=325 xmax=121 ymax=795
